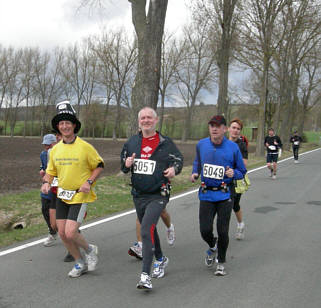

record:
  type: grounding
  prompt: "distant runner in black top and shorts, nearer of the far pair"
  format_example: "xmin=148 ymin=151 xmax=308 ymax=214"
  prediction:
xmin=264 ymin=128 xmax=282 ymax=180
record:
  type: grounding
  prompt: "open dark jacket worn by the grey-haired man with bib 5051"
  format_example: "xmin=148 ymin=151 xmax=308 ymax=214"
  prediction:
xmin=120 ymin=133 xmax=183 ymax=196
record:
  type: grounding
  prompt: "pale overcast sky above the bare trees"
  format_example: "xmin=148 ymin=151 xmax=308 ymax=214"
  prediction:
xmin=0 ymin=0 xmax=188 ymax=48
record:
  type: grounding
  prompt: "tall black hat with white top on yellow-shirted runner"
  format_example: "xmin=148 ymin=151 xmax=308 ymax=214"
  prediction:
xmin=51 ymin=101 xmax=81 ymax=134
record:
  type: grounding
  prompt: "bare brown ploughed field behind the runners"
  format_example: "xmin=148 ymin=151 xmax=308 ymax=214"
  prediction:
xmin=0 ymin=137 xmax=196 ymax=193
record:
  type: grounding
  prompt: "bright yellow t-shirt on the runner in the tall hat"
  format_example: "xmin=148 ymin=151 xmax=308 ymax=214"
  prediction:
xmin=46 ymin=137 xmax=104 ymax=204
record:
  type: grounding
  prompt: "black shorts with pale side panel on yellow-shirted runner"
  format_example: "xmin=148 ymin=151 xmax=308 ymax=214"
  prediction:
xmin=56 ymin=198 xmax=87 ymax=223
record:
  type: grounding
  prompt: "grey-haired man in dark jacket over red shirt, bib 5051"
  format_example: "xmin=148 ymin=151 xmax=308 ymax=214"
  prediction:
xmin=121 ymin=107 xmax=183 ymax=289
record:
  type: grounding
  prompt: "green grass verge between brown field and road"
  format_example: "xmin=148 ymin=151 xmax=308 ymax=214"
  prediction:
xmin=0 ymin=143 xmax=317 ymax=247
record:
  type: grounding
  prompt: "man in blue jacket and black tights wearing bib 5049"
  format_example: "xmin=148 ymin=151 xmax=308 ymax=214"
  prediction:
xmin=191 ymin=115 xmax=246 ymax=276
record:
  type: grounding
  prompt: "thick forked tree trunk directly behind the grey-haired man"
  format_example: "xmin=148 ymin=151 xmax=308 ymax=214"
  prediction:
xmin=129 ymin=0 xmax=168 ymax=134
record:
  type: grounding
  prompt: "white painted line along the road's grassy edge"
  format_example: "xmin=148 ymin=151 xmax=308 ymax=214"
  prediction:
xmin=0 ymin=148 xmax=321 ymax=257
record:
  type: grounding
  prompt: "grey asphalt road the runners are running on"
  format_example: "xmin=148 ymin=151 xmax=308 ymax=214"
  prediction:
xmin=0 ymin=151 xmax=321 ymax=308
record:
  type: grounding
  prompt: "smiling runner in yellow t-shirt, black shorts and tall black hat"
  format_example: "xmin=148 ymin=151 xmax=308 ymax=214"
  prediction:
xmin=41 ymin=101 xmax=104 ymax=278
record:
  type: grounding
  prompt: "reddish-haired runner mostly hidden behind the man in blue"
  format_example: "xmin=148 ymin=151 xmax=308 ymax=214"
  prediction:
xmin=228 ymin=118 xmax=248 ymax=240
